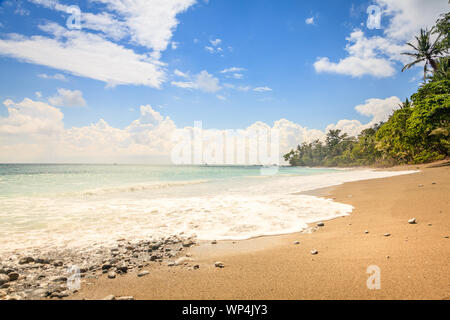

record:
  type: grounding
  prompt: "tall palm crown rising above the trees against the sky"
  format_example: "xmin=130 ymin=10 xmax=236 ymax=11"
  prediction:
xmin=402 ymin=28 xmax=442 ymax=81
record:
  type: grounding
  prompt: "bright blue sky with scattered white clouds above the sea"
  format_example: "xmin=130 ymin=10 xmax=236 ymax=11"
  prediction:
xmin=0 ymin=0 xmax=450 ymax=163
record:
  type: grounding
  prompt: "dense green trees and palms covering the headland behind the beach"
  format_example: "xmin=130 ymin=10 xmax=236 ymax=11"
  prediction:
xmin=284 ymin=13 xmax=450 ymax=166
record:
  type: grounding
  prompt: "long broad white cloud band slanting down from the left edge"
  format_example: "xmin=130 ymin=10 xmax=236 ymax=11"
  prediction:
xmin=0 ymin=24 xmax=165 ymax=88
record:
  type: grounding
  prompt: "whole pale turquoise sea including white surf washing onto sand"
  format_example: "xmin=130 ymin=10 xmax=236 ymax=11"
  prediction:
xmin=0 ymin=164 xmax=413 ymax=254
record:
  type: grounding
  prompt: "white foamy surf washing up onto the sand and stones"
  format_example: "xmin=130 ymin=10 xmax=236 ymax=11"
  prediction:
xmin=0 ymin=169 xmax=417 ymax=252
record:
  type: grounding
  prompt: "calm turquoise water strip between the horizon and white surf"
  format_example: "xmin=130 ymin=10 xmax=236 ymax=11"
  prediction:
xmin=0 ymin=164 xmax=335 ymax=196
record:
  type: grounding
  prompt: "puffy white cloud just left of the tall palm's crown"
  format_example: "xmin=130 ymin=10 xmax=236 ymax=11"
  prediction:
xmin=314 ymin=0 xmax=448 ymax=78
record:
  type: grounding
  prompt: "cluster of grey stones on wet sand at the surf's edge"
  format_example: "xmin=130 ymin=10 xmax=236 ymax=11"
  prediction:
xmin=0 ymin=236 xmax=195 ymax=300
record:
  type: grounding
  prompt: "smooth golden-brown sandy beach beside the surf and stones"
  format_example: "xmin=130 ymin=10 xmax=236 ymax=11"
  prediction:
xmin=68 ymin=162 xmax=450 ymax=299
